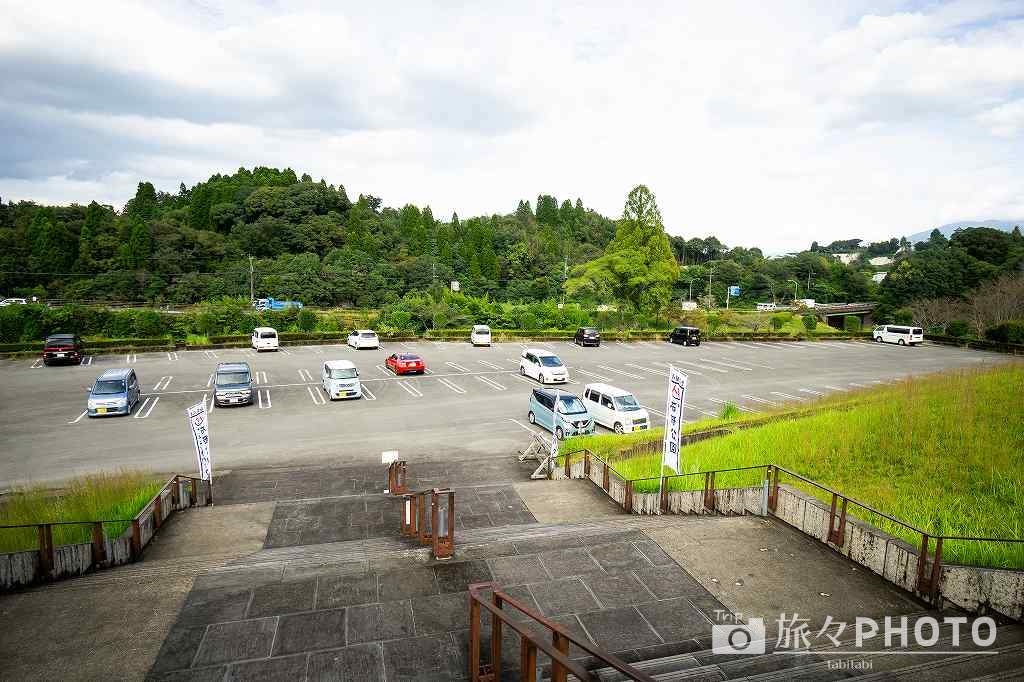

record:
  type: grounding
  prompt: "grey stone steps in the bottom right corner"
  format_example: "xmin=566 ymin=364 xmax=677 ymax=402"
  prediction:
xmin=594 ymin=611 xmax=1024 ymax=682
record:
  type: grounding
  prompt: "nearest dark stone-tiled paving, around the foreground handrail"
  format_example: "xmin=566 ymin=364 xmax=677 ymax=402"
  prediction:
xmin=151 ymin=531 xmax=725 ymax=681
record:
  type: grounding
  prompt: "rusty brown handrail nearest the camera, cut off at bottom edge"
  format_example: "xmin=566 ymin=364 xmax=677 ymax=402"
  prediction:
xmin=469 ymin=583 xmax=654 ymax=682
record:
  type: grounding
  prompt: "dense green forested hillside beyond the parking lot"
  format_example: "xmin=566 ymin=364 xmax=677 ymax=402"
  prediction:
xmin=0 ymin=168 xmax=1024 ymax=313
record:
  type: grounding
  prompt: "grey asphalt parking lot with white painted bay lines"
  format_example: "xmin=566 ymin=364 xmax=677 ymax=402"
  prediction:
xmin=0 ymin=341 xmax=1008 ymax=486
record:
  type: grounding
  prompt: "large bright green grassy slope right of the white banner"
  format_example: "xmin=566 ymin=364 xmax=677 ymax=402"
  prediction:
xmin=563 ymin=366 xmax=1024 ymax=567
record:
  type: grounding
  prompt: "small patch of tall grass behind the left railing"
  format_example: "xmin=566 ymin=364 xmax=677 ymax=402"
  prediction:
xmin=0 ymin=471 xmax=166 ymax=552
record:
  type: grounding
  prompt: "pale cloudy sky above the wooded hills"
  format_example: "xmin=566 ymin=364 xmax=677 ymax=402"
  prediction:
xmin=0 ymin=0 xmax=1024 ymax=252
